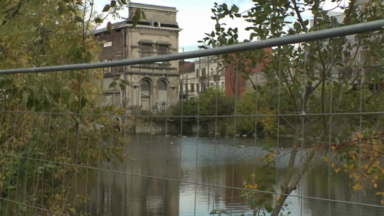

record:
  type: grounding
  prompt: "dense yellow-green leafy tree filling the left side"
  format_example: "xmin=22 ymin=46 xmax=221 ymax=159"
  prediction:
xmin=0 ymin=0 xmax=129 ymax=215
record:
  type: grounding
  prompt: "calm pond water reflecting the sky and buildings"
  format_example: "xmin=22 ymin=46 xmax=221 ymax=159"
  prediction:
xmin=78 ymin=134 xmax=384 ymax=216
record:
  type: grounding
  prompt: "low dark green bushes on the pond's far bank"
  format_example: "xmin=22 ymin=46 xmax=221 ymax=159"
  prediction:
xmin=159 ymin=88 xmax=276 ymax=136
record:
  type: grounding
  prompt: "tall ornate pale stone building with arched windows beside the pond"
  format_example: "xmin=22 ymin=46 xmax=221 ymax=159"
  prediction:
xmin=95 ymin=3 xmax=181 ymax=112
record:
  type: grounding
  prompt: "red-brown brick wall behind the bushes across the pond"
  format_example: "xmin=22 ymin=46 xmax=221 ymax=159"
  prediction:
xmin=225 ymin=48 xmax=272 ymax=97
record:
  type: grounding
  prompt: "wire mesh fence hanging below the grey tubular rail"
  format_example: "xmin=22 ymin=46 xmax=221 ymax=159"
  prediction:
xmin=0 ymin=21 xmax=384 ymax=215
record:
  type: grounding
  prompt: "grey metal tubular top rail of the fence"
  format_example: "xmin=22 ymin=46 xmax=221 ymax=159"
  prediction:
xmin=0 ymin=19 xmax=384 ymax=75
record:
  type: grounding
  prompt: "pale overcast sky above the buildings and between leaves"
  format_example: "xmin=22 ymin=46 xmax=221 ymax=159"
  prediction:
xmin=95 ymin=0 xmax=346 ymax=52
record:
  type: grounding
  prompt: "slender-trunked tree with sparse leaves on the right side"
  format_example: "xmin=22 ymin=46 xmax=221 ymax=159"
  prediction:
xmin=201 ymin=0 xmax=384 ymax=216
